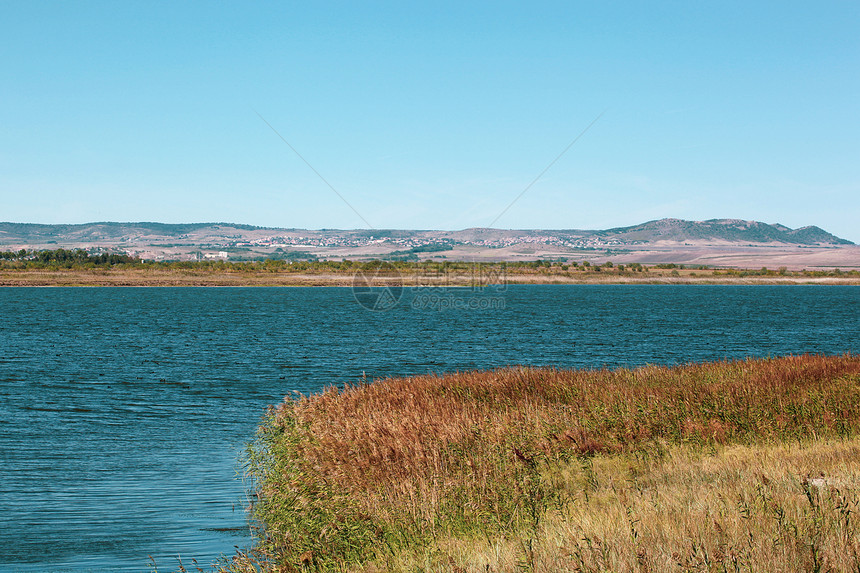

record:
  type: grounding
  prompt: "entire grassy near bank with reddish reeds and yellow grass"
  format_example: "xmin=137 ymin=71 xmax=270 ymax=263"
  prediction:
xmin=224 ymin=355 xmax=860 ymax=572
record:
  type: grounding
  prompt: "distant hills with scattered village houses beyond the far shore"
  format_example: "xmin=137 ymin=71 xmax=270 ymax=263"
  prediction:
xmin=0 ymin=219 xmax=848 ymax=268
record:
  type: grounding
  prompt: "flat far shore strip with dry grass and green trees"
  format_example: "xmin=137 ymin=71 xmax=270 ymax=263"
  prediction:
xmin=0 ymin=249 xmax=860 ymax=286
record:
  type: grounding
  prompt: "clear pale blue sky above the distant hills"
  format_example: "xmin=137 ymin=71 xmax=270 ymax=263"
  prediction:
xmin=0 ymin=0 xmax=860 ymax=242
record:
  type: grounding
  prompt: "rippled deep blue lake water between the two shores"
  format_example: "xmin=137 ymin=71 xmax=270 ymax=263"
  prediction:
xmin=0 ymin=285 xmax=860 ymax=571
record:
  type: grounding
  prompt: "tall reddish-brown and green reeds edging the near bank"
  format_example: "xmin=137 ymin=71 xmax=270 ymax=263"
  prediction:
xmin=225 ymin=354 xmax=860 ymax=571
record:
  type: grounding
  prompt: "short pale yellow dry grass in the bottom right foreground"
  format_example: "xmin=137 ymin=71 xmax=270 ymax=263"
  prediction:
xmin=404 ymin=439 xmax=860 ymax=573
